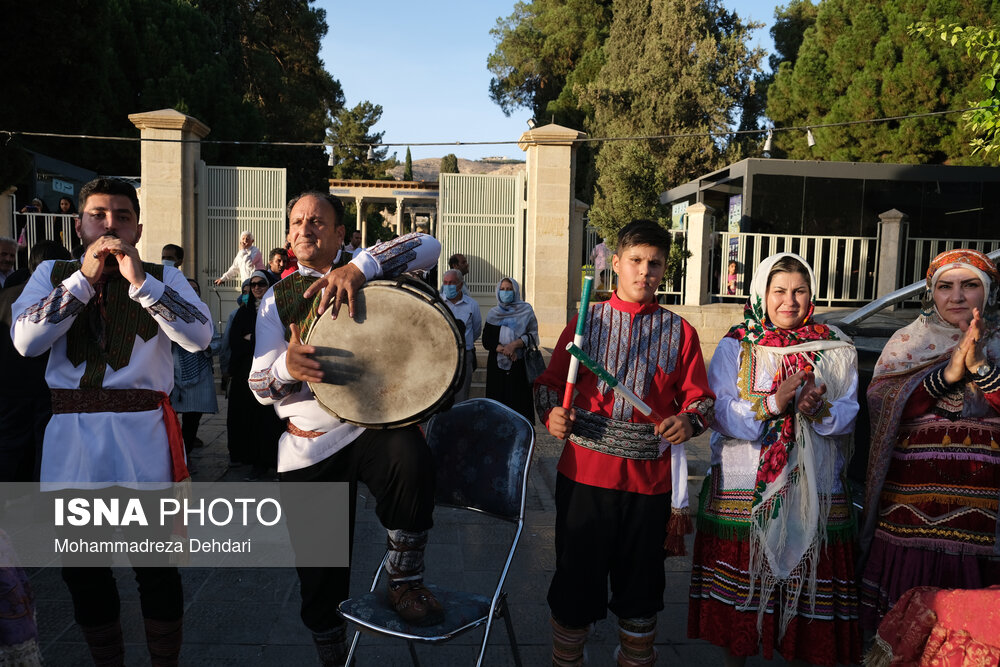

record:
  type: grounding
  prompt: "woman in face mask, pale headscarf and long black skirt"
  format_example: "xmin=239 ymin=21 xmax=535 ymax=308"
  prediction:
xmin=483 ymin=278 xmax=538 ymax=424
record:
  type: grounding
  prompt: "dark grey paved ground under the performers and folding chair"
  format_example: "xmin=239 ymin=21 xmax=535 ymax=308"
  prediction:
xmin=31 ymin=400 xmax=804 ymax=667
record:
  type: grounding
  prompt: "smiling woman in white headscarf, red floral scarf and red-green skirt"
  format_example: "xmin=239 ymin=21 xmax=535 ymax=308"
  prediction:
xmin=688 ymin=253 xmax=861 ymax=665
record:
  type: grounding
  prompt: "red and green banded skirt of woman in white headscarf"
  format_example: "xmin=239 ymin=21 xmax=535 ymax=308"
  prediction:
xmin=688 ymin=474 xmax=861 ymax=665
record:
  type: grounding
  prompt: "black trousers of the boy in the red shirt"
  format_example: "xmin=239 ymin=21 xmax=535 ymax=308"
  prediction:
xmin=548 ymin=474 xmax=670 ymax=627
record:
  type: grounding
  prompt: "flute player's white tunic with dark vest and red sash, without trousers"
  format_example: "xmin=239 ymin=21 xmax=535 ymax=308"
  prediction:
xmin=11 ymin=261 xmax=212 ymax=488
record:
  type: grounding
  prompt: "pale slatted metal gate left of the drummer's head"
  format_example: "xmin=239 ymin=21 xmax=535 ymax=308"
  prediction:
xmin=197 ymin=162 xmax=287 ymax=331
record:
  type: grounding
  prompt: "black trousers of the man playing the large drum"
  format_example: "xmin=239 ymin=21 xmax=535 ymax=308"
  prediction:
xmin=281 ymin=426 xmax=434 ymax=632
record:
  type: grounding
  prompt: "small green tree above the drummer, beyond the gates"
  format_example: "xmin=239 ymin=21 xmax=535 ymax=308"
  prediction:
xmin=327 ymin=100 xmax=396 ymax=180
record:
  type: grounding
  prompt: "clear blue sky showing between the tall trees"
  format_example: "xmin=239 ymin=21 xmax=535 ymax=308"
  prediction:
xmin=315 ymin=0 xmax=775 ymax=160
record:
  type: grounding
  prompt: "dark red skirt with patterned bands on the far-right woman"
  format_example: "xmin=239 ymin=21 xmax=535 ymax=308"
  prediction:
xmin=861 ymin=416 xmax=1000 ymax=629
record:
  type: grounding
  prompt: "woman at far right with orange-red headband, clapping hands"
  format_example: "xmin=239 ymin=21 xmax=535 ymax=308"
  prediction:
xmin=861 ymin=250 xmax=1000 ymax=630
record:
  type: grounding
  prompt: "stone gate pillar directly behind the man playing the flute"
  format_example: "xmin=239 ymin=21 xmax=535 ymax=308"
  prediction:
xmin=128 ymin=109 xmax=210 ymax=278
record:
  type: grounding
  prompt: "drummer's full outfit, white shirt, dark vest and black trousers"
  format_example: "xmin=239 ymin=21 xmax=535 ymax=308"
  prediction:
xmin=249 ymin=234 xmax=441 ymax=640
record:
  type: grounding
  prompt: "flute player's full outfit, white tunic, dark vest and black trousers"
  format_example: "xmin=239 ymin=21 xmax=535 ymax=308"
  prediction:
xmin=11 ymin=252 xmax=212 ymax=664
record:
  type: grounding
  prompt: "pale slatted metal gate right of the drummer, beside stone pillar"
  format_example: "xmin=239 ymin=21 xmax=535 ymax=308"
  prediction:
xmin=438 ymin=173 xmax=525 ymax=298
